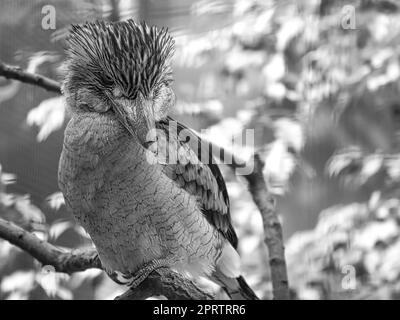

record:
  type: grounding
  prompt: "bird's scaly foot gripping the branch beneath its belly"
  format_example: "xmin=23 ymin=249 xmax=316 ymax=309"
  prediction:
xmin=111 ymin=259 xmax=171 ymax=289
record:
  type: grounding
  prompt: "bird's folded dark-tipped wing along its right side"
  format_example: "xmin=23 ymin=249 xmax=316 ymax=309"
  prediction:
xmin=149 ymin=117 xmax=238 ymax=249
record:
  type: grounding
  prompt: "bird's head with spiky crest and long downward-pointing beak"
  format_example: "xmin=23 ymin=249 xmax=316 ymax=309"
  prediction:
xmin=62 ymin=20 xmax=175 ymax=142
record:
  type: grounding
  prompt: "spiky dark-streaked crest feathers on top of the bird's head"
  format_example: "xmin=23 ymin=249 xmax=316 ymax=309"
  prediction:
xmin=66 ymin=19 xmax=174 ymax=99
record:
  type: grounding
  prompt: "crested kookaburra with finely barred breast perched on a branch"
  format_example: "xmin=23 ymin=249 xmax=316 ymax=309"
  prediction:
xmin=58 ymin=19 xmax=258 ymax=299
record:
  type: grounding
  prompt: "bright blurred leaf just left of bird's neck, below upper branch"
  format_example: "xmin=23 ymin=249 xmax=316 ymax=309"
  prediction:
xmin=26 ymin=96 xmax=65 ymax=142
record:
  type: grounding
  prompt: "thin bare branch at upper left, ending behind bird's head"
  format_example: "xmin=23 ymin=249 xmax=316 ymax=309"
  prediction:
xmin=0 ymin=61 xmax=61 ymax=94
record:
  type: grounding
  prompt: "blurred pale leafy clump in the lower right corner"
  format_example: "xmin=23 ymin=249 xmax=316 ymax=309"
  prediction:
xmin=286 ymin=193 xmax=400 ymax=299
